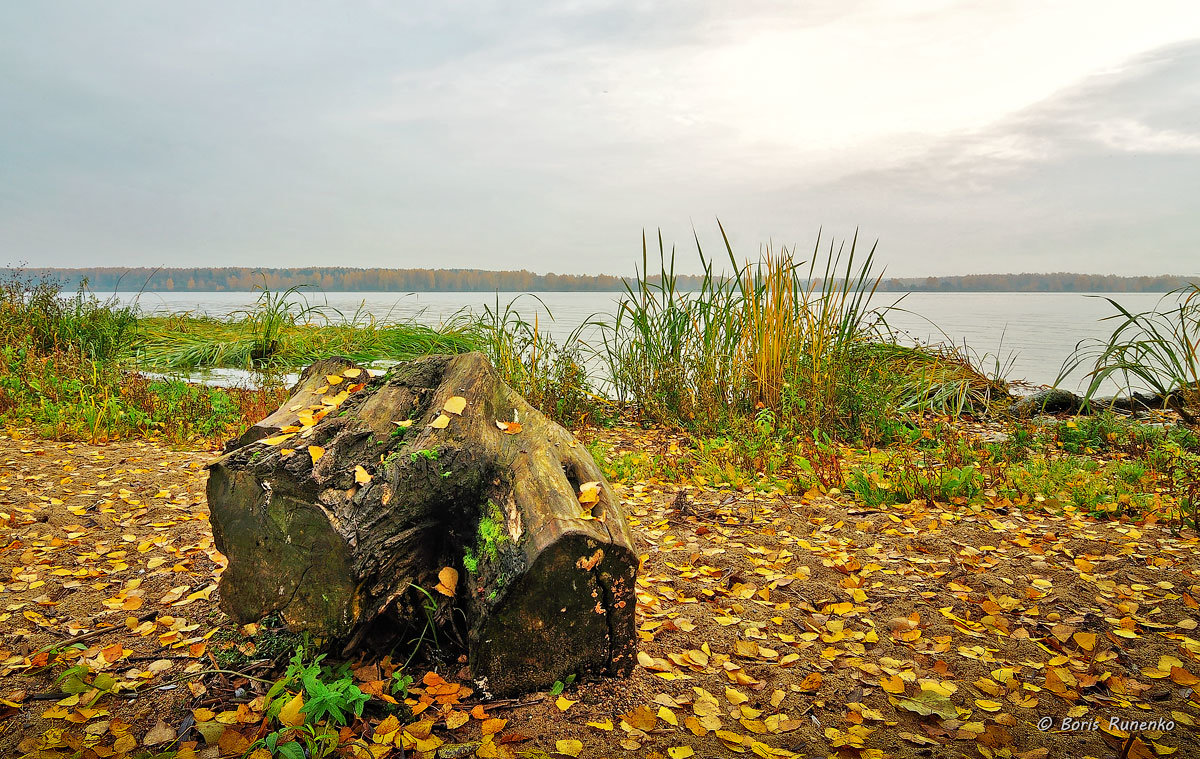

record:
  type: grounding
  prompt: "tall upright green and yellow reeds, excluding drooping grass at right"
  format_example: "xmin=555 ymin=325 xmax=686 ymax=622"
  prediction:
xmin=602 ymin=222 xmax=902 ymax=441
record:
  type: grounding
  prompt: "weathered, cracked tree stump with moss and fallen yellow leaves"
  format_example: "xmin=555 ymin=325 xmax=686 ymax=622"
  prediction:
xmin=208 ymin=353 xmax=637 ymax=695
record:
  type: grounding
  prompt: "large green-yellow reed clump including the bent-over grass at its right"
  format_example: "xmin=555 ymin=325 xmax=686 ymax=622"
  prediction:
xmin=601 ymin=222 xmax=1007 ymax=443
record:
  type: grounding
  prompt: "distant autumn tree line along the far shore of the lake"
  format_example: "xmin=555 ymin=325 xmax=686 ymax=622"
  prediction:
xmin=23 ymin=267 xmax=1200 ymax=293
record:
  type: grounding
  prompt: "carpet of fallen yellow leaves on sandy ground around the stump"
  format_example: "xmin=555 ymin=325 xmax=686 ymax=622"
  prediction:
xmin=0 ymin=425 xmax=1200 ymax=759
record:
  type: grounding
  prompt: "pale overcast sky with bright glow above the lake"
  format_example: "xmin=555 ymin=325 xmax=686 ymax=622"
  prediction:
xmin=0 ymin=0 xmax=1200 ymax=276
